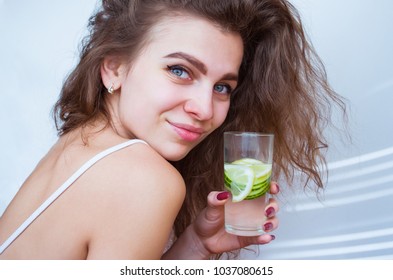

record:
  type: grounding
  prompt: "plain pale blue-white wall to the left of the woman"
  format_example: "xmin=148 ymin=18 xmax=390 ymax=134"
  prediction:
xmin=0 ymin=0 xmax=95 ymax=213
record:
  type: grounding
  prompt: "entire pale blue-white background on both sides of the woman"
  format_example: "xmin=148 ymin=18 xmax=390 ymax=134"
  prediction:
xmin=0 ymin=0 xmax=393 ymax=259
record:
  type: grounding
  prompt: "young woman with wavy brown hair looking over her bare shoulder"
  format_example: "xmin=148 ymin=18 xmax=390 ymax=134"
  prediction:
xmin=0 ymin=0 xmax=342 ymax=259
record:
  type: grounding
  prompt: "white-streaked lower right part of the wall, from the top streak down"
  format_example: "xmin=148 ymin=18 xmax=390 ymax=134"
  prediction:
xmin=242 ymin=146 xmax=393 ymax=259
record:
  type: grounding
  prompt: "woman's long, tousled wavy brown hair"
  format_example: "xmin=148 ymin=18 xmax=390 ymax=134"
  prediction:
xmin=54 ymin=0 xmax=345 ymax=238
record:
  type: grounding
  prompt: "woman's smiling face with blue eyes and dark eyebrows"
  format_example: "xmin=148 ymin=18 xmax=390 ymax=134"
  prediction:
xmin=113 ymin=17 xmax=243 ymax=161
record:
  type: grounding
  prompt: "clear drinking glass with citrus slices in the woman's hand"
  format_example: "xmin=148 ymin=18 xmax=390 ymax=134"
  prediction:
xmin=224 ymin=132 xmax=274 ymax=236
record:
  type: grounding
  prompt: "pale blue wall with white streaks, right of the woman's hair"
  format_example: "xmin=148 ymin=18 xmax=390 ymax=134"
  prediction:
xmin=244 ymin=0 xmax=393 ymax=259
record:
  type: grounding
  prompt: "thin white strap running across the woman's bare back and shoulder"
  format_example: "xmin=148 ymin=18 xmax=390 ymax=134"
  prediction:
xmin=0 ymin=139 xmax=147 ymax=255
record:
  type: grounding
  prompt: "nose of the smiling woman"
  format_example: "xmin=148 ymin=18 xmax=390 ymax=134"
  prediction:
xmin=184 ymin=88 xmax=213 ymax=121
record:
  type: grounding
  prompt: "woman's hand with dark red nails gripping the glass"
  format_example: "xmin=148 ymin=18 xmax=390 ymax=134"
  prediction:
xmin=163 ymin=182 xmax=279 ymax=259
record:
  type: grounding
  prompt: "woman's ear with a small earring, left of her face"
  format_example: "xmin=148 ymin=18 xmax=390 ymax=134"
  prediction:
xmin=101 ymin=56 xmax=126 ymax=90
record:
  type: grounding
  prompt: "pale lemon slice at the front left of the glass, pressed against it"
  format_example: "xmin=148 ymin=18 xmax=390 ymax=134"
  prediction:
xmin=224 ymin=164 xmax=254 ymax=202
